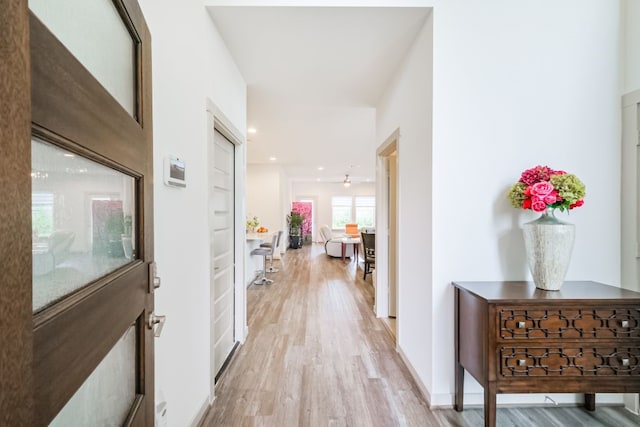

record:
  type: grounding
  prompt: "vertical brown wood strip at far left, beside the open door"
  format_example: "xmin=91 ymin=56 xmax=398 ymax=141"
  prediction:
xmin=0 ymin=0 xmax=34 ymax=425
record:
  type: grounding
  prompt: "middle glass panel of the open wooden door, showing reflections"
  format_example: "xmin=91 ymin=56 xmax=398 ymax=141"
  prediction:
xmin=31 ymin=139 xmax=136 ymax=311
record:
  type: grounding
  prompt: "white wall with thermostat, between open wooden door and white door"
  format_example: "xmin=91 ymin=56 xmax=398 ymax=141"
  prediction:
xmin=140 ymin=0 xmax=246 ymax=426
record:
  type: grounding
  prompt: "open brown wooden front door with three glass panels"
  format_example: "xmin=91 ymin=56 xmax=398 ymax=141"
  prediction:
xmin=29 ymin=0 xmax=155 ymax=426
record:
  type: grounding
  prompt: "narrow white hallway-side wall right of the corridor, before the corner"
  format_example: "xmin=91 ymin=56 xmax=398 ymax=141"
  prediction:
xmin=377 ymin=7 xmax=436 ymax=398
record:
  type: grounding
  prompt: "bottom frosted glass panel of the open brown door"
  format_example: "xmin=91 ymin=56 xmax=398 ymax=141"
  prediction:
xmin=49 ymin=326 xmax=136 ymax=427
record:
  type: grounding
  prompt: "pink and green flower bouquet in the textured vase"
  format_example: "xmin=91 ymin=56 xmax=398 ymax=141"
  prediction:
xmin=508 ymin=166 xmax=585 ymax=212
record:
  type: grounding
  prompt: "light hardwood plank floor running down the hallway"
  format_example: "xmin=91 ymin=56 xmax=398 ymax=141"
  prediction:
xmin=201 ymin=245 xmax=640 ymax=427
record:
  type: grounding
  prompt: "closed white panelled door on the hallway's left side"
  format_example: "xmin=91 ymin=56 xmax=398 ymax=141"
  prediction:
xmin=209 ymin=130 xmax=236 ymax=380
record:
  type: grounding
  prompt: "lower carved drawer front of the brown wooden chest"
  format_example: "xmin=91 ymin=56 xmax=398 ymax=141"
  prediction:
xmin=500 ymin=343 xmax=640 ymax=377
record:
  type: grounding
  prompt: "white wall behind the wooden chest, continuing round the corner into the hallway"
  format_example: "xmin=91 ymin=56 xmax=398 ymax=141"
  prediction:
xmin=377 ymin=0 xmax=620 ymax=406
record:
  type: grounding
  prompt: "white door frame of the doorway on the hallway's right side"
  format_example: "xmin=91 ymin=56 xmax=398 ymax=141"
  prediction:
xmin=373 ymin=128 xmax=400 ymax=326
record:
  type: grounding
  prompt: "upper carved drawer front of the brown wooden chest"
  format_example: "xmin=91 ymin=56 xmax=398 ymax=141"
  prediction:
xmin=498 ymin=307 xmax=640 ymax=340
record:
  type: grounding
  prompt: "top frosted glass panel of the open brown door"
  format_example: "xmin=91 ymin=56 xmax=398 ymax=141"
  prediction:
xmin=29 ymin=0 xmax=136 ymax=116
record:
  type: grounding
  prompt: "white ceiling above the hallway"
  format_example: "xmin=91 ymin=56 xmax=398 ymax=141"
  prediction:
xmin=207 ymin=6 xmax=430 ymax=182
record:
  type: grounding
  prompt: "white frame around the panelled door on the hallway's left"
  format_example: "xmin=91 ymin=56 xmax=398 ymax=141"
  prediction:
xmin=206 ymin=98 xmax=249 ymax=404
